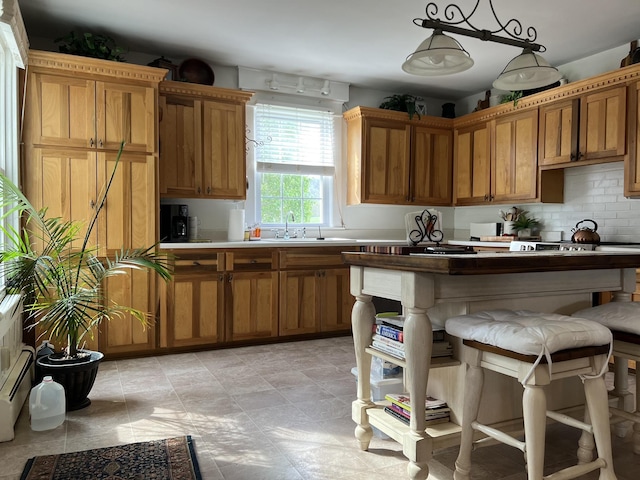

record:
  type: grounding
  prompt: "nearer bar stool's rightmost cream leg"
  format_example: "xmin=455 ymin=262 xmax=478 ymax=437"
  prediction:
xmin=584 ymin=377 xmax=616 ymax=480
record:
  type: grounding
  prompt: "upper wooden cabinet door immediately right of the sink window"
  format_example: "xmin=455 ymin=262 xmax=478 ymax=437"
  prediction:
xmin=362 ymin=119 xmax=411 ymax=204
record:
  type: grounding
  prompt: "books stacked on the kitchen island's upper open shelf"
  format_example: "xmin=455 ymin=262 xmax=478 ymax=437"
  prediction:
xmin=371 ymin=313 xmax=453 ymax=360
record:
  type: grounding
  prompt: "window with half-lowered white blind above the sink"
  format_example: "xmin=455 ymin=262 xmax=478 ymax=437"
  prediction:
xmin=254 ymin=104 xmax=336 ymax=226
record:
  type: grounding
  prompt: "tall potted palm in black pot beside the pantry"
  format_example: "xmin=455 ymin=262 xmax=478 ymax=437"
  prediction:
xmin=0 ymin=143 xmax=171 ymax=410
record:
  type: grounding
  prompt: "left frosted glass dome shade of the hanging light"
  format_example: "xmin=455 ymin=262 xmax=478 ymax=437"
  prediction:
xmin=402 ymin=30 xmax=473 ymax=76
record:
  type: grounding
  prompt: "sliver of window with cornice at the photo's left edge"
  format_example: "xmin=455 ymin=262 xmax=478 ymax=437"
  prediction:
xmin=0 ymin=0 xmax=28 ymax=297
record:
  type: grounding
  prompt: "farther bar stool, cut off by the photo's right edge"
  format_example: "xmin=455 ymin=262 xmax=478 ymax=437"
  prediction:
xmin=574 ymin=301 xmax=640 ymax=460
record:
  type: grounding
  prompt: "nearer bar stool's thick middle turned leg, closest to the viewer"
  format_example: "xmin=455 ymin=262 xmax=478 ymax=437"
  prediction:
xmin=522 ymin=385 xmax=547 ymax=480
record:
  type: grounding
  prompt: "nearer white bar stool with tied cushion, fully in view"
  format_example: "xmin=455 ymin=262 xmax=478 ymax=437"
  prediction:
xmin=446 ymin=310 xmax=616 ymax=480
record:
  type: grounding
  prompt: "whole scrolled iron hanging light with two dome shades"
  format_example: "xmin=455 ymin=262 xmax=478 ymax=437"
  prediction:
xmin=402 ymin=0 xmax=561 ymax=91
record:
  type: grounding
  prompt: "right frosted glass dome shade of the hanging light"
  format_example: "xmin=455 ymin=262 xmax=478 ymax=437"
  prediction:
xmin=493 ymin=48 xmax=562 ymax=91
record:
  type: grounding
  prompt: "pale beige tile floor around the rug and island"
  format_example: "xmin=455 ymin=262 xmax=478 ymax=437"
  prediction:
xmin=0 ymin=337 xmax=640 ymax=480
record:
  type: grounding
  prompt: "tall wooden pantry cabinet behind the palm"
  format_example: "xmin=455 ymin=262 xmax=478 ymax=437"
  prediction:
xmin=21 ymin=50 xmax=166 ymax=354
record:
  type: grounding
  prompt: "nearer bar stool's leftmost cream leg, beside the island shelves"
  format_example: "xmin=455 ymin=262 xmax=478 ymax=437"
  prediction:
xmin=453 ymin=365 xmax=484 ymax=480
